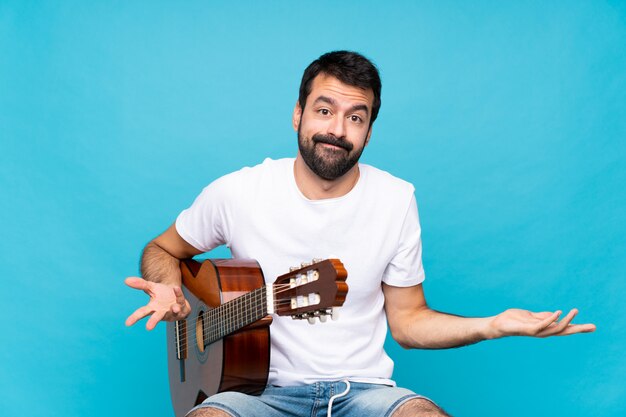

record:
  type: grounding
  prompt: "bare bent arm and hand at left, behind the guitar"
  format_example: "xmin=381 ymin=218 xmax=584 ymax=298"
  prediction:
xmin=125 ymin=224 xmax=201 ymax=330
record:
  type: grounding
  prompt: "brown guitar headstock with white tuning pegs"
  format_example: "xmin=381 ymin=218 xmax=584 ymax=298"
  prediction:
xmin=273 ymin=259 xmax=348 ymax=324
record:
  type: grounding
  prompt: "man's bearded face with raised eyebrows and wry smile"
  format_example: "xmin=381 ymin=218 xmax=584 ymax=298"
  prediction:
xmin=293 ymin=74 xmax=374 ymax=181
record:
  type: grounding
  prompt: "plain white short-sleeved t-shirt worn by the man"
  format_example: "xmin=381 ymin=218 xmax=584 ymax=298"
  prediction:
xmin=176 ymin=158 xmax=424 ymax=386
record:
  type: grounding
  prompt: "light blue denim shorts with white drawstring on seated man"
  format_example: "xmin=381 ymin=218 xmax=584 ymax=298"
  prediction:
xmin=185 ymin=381 xmax=430 ymax=417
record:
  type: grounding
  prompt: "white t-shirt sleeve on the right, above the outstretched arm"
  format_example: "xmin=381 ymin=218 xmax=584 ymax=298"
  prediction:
xmin=383 ymin=196 xmax=425 ymax=287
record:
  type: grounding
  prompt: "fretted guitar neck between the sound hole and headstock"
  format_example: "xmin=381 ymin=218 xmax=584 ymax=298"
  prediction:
xmin=203 ymin=286 xmax=266 ymax=345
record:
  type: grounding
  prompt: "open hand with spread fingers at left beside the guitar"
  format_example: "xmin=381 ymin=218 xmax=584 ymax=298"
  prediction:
xmin=124 ymin=277 xmax=191 ymax=330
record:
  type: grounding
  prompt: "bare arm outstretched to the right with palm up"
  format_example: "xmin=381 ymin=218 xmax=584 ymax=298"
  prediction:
xmin=383 ymin=284 xmax=596 ymax=349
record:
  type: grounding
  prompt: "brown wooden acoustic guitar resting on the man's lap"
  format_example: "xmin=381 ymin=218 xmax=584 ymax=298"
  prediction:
xmin=167 ymin=259 xmax=348 ymax=417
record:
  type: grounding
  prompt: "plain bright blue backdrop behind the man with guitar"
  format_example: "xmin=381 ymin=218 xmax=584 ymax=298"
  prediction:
xmin=0 ymin=0 xmax=626 ymax=417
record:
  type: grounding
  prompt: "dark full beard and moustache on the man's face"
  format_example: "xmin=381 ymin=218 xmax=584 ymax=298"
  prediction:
xmin=298 ymin=129 xmax=365 ymax=181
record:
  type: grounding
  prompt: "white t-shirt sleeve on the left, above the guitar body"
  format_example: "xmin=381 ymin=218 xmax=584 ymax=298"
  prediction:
xmin=176 ymin=177 xmax=230 ymax=252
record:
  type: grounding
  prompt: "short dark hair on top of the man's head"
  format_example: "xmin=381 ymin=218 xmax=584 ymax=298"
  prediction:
xmin=298 ymin=51 xmax=382 ymax=126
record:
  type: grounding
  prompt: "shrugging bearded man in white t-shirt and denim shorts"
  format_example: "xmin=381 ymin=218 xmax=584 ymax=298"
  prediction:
xmin=126 ymin=51 xmax=595 ymax=417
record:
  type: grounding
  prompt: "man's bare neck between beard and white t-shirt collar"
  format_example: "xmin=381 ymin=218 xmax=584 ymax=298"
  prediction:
xmin=293 ymin=152 xmax=360 ymax=200
